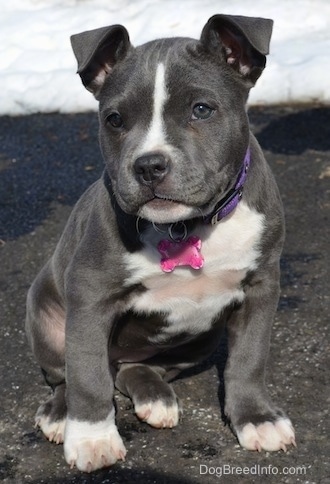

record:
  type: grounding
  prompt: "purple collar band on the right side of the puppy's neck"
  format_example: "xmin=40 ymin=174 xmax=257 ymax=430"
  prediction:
xmin=205 ymin=147 xmax=251 ymax=225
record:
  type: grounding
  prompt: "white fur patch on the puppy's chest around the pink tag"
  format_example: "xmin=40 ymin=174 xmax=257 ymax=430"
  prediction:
xmin=125 ymin=203 xmax=264 ymax=333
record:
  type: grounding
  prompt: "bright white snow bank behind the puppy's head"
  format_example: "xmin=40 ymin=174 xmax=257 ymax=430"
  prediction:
xmin=0 ymin=0 xmax=330 ymax=115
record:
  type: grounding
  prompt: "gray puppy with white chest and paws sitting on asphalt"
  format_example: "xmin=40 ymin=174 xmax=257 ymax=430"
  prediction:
xmin=26 ymin=15 xmax=295 ymax=471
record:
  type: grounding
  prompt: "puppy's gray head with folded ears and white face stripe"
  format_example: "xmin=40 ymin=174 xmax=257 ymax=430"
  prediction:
xmin=71 ymin=15 xmax=272 ymax=223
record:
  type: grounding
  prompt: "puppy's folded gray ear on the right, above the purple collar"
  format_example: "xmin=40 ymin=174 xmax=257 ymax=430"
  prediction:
xmin=201 ymin=15 xmax=273 ymax=84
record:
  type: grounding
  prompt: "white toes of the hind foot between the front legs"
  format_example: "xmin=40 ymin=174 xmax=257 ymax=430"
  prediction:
xmin=135 ymin=400 xmax=180 ymax=429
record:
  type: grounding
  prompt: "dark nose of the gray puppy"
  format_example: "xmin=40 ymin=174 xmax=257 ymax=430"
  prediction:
xmin=134 ymin=153 xmax=170 ymax=185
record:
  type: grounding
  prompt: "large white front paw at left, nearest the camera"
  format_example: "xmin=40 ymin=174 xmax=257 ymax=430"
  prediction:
xmin=64 ymin=412 xmax=126 ymax=472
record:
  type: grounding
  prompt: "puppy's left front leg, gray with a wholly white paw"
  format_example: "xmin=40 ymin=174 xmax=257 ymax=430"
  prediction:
xmin=64 ymin=302 xmax=126 ymax=472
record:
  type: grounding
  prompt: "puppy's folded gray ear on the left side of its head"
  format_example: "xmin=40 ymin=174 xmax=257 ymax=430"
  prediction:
xmin=70 ymin=25 xmax=131 ymax=98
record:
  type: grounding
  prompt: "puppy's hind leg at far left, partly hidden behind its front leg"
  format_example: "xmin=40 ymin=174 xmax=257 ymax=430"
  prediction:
xmin=26 ymin=266 xmax=66 ymax=444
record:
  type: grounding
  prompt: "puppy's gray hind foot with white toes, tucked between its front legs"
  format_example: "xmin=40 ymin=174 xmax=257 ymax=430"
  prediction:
xmin=116 ymin=363 xmax=180 ymax=428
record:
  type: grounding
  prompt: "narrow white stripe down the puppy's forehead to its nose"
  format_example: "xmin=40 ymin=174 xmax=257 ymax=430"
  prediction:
xmin=140 ymin=63 xmax=168 ymax=154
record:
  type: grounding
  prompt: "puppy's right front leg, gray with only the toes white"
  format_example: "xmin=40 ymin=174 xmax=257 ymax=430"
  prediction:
xmin=225 ymin=265 xmax=295 ymax=451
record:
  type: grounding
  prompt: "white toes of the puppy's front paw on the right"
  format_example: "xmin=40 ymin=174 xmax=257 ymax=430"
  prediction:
xmin=237 ymin=418 xmax=296 ymax=452
